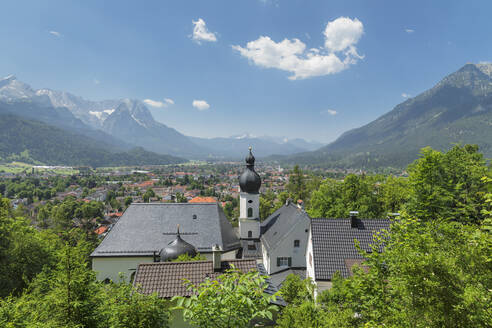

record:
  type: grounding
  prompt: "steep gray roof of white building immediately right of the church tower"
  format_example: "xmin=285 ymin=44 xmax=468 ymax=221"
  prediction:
xmin=261 ymin=203 xmax=309 ymax=249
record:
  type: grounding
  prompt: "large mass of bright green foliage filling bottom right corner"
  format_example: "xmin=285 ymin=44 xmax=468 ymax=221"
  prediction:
xmin=318 ymin=219 xmax=492 ymax=327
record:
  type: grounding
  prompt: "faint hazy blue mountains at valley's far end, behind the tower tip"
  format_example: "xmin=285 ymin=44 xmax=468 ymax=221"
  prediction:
xmin=190 ymin=134 xmax=322 ymax=159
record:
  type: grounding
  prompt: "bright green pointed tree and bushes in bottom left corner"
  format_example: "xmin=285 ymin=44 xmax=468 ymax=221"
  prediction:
xmin=0 ymin=230 xmax=169 ymax=328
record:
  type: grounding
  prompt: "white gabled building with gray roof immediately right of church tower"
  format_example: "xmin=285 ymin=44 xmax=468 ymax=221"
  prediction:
xmin=260 ymin=201 xmax=310 ymax=274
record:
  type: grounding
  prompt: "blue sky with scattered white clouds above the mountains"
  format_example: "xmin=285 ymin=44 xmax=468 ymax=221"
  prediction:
xmin=0 ymin=0 xmax=492 ymax=142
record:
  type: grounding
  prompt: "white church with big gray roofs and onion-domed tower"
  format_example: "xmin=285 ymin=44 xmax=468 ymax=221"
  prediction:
xmin=91 ymin=147 xmax=309 ymax=281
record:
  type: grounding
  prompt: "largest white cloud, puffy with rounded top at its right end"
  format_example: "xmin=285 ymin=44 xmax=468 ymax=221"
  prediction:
xmin=232 ymin=17 xmax=364 ymax=80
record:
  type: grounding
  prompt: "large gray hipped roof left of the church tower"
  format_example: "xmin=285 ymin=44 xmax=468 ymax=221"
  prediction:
xmin=91 ymin=203 xmax=241 ymax=257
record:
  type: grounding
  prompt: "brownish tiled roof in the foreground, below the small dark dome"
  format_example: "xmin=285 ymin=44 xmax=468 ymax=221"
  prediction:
xmin=133 ymin=260 xmax=285 ymax=305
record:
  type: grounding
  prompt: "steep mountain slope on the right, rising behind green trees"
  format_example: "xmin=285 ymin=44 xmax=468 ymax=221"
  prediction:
xmin=280 ymin=64 xmax=492 ymax=168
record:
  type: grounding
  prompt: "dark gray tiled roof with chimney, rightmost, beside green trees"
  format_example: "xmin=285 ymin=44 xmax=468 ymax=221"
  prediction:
xmin=311 ymin=218 xmax=391 ymax=280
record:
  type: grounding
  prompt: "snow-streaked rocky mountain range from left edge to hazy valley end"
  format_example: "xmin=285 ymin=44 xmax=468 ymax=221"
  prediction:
xmin=0 ymin=76 xmax=322 ymax=159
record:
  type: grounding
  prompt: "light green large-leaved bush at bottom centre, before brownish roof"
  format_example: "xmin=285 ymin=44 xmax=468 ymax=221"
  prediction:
xmin=173 ymin=268 xmax=277 ymax=328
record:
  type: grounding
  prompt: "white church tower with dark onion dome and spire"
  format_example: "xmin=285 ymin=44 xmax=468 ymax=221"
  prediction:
xmin=239 ymin=147 xmax=261 ymax=239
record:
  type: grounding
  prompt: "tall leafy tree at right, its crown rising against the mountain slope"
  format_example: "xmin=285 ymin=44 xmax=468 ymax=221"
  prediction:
xmin=406 ymin=145 xmax=488 ymax=223
